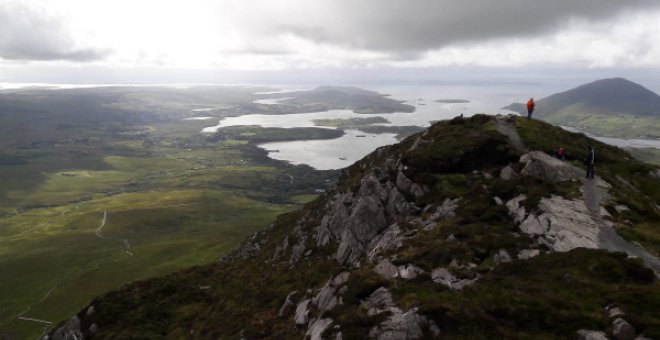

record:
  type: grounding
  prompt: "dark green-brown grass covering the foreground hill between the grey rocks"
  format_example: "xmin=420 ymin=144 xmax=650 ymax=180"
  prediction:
xmin=49 ymin=115 xmax=660 ymax=339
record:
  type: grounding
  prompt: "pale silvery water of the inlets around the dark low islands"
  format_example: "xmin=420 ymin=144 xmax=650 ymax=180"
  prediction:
xmin=202 ymin=82 xmax=660 ymax=170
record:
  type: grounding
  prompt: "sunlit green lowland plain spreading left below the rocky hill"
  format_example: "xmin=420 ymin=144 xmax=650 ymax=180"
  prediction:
xmin=0 ymin=87 xmax=360 ymax=339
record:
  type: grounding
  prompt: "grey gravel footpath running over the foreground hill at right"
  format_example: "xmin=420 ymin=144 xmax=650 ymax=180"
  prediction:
xmin=495 ymin=117 xmax=660 ymax=277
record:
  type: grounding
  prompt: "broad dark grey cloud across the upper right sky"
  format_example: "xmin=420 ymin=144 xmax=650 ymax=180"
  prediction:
xmin=260 ymin=0 xmax=660 ymax=53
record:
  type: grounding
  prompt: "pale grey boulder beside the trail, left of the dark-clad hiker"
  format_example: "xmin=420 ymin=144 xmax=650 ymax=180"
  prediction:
xmin=520 ymin=151 xmax=579 ymax=183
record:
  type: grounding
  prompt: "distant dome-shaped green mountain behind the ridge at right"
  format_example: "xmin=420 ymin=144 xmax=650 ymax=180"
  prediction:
xmin=504 ymin=78 xmax=660 ymax=138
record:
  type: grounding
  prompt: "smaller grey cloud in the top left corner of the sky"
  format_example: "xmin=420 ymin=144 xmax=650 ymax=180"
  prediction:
xmin=0 ymin=2 xmax=107 ymax=61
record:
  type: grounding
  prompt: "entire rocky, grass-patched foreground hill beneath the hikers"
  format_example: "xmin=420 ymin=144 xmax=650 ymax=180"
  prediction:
xmin=48 ymin=115 xmax=660 ymax=339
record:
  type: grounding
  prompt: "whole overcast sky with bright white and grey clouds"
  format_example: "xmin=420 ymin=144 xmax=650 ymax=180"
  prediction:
xmin=0 ymin=0 xmax=660 ymax=82
